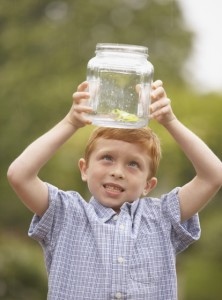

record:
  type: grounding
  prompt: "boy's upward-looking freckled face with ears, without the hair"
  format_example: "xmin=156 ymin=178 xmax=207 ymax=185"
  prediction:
xmin=79 ymin=138 xmax=157 ymax=211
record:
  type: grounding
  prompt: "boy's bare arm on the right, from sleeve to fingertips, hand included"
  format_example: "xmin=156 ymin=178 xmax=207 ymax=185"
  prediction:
xmin=151 ymin=81 xmax=222 ymax=221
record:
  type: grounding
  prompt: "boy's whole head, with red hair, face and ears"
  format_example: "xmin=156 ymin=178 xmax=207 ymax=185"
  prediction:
xmin=79 ymin=128 xmax=161 ymax=211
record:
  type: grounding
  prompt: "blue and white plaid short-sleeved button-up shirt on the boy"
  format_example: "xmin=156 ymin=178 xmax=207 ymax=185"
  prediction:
xmin=29 ymin=185 xmax=200 ymax=300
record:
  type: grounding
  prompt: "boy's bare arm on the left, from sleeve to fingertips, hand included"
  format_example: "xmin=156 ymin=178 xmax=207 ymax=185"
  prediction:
xmin=7 ymin=82 xmax=91 ymax=216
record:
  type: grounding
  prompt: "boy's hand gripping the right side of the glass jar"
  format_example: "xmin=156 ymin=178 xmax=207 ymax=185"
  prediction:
xmin=149 ymin=80 xmax=176 ymax=125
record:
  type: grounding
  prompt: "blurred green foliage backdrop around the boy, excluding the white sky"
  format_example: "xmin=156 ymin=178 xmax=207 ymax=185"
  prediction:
xmin=0 ymin=0 xmax=222 ymax=300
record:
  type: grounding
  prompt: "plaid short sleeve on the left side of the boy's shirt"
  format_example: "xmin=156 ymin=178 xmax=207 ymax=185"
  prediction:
xmin=28 ymin=184 xmax=88 ymax=271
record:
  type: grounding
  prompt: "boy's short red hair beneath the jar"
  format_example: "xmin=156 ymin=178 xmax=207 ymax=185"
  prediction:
xmin=84 ymin=127 xmax=161 ymax=177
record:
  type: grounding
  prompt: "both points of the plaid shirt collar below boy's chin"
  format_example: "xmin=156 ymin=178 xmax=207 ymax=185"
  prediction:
xmin=89 ymin=197 xmax=139 ymax=222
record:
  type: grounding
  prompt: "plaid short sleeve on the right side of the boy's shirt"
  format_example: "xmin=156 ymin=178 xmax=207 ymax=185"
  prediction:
xmin=161 ymin=188 xmax=201 ymax=254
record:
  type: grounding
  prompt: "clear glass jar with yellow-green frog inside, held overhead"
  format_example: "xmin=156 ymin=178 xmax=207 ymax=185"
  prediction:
xmin=87 ymin=43 xmax=153 ymax=128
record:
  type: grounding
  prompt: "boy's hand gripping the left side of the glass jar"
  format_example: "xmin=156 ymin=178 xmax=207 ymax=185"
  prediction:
xmin=66 ymin=81 xmax=92 ymax=129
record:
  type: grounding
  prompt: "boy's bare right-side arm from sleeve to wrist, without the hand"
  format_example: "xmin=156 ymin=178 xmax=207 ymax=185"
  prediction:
xmin=165 ymin=119 xmax=222 ymax=221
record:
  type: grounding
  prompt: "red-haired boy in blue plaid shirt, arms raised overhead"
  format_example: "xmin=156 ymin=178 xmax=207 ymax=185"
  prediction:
xmin=8 ymin=80 xmax=222 ymax=300
